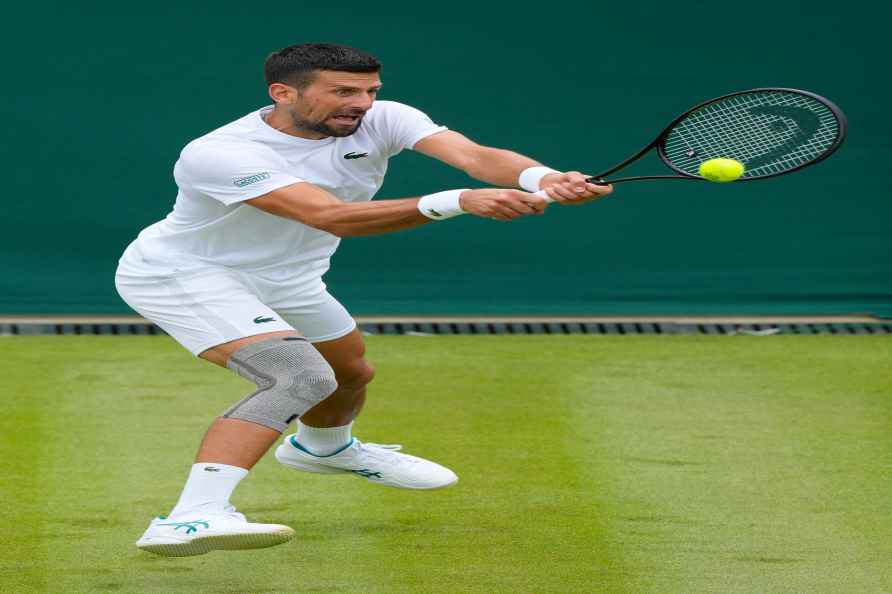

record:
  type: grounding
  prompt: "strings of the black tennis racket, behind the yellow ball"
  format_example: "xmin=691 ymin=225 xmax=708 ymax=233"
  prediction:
xmin=663 ymin=91 xmax=840 ymax=177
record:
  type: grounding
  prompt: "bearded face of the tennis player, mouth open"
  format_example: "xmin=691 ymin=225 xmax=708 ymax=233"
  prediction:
xmin=289 ymin=70 xmax=381 ymax=137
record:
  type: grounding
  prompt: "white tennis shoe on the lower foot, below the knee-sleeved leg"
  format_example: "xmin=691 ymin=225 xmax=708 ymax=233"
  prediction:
xmin=136 ymin=506 xmax=294 ymax=557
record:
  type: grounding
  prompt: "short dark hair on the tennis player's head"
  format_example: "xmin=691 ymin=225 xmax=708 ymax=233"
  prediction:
xmin=263 ymin=43 xmax=381 ymax=89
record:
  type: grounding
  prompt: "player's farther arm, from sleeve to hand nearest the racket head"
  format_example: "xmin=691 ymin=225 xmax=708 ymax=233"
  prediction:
xmin=413 ymin=130 xmax=613 ymax=204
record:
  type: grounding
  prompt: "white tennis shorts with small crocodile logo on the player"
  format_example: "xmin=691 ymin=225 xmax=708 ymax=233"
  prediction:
xmin=115 ymin=265 xmax=356 ymax=355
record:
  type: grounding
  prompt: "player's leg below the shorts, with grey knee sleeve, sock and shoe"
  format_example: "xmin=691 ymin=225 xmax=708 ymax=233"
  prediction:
xmin=136 ymin=330 xmax=334 ymax=556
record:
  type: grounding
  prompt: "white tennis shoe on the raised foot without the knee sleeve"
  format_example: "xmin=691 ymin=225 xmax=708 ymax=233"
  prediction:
xmin=276 ymin=434 xmax=458 ymax=489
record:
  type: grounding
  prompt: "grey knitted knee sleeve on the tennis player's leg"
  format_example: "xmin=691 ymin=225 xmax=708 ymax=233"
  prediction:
xmin=223 ymin=336 xmax=338 ymax=432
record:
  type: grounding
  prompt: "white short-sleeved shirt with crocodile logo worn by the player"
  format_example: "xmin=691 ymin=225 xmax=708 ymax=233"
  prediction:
xmin=121 ymin=101 xmax=446 ymax=287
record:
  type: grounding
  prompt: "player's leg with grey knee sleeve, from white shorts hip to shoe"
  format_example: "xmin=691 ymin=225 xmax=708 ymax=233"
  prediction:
xmin=115 ymin=266 xmax=336 ymax=556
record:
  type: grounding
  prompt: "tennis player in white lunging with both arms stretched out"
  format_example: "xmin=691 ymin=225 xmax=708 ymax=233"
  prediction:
xmin=115 ymin=44 xmax=612 ymax=556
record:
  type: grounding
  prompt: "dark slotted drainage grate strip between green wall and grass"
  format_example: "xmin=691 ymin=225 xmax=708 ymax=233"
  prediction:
xmin=0 ymin=319 xmax=892 ymax=336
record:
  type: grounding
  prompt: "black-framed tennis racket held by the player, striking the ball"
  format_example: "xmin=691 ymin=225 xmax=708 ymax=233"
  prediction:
xmin=536 ymin=88 xmax=847 ymax=201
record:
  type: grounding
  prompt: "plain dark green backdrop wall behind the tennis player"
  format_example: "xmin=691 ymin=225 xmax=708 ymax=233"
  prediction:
xmin=0 ymin=0 xmax=892 ymax=315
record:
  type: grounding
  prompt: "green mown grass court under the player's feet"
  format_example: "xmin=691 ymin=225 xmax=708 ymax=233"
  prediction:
xmin=0 ymin=336 xmax=892 ymax=594
